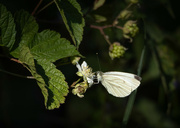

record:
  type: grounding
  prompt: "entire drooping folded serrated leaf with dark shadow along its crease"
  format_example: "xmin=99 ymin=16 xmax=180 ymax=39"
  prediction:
xmin=19 ymin=46 xmax=69 ymax=109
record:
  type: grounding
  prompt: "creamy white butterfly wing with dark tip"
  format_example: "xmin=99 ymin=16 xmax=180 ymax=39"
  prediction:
xmin=101 ymin=72 xmax=141 ymax=97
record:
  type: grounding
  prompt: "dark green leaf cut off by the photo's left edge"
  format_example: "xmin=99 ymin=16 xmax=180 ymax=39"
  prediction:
xmin=0 ymin=4 xmax=16 ymax=50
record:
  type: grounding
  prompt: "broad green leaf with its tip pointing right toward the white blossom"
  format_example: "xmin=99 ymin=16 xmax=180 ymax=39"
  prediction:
xmin=31 ymin=30 xmax=80 ymax=62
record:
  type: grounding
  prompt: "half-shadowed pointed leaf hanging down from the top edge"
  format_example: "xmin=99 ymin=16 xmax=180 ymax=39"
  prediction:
xmin=54 ymin=0 xmax=85 ymax=48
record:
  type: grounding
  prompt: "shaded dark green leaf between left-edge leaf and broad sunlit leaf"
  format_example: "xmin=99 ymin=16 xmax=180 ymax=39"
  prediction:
xmin=11 ymin=10 xmax=38 ymax=58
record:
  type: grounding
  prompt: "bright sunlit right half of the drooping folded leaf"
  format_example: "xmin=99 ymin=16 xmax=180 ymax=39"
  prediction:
xmin=37 ymin=59 xmax=69 ymax=109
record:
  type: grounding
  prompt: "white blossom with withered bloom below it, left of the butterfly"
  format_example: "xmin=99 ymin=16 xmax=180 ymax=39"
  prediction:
xmin=72 ymin=61 xmax=93 ymax=98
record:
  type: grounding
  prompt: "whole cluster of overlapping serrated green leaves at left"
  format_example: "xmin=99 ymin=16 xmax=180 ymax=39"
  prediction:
xmin=0 ymin=5 xmax=80 ymax=109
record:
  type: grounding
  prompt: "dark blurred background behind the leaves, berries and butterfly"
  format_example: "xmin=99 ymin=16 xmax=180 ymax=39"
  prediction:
xmin=0 ymin=0 xmax=180 ymax=128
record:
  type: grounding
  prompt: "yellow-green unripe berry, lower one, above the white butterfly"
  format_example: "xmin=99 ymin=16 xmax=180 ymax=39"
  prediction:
xmin=109 ymin=42 xmax=126 ymax=60
